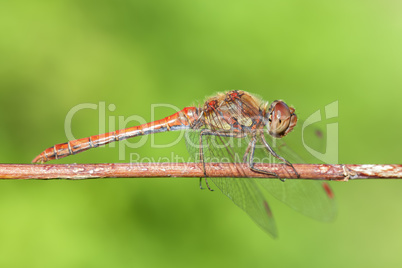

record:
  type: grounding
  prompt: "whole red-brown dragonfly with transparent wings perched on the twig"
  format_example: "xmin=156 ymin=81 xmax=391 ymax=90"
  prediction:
xmin=32 ymin=90 xmax=336 ymax=237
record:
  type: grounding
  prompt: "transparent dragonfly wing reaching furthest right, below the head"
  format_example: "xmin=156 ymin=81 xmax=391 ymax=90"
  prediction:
xmin=256 ymin=120 xmax=337 ymax=221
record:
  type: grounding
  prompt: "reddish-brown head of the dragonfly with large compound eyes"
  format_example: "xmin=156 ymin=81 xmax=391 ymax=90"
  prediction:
xmin=267 ymin=100 xmax=297 ymax=138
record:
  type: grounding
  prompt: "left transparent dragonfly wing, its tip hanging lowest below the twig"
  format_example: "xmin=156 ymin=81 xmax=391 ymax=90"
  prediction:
xmin=186 ymin=131 xmax=277 ymax=237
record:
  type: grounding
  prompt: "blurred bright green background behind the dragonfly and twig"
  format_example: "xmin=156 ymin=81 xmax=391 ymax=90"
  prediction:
xmin=0 ymin=0 xmax=402 ymax=267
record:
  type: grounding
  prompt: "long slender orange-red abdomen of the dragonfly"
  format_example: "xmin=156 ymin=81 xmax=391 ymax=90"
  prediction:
xmin=32 ymin=107 xmax=198 ymax=163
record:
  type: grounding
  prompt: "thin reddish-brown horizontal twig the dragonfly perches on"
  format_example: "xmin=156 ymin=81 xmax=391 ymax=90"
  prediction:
xmin=0 ymin=163 xmax=402 ymax=181
